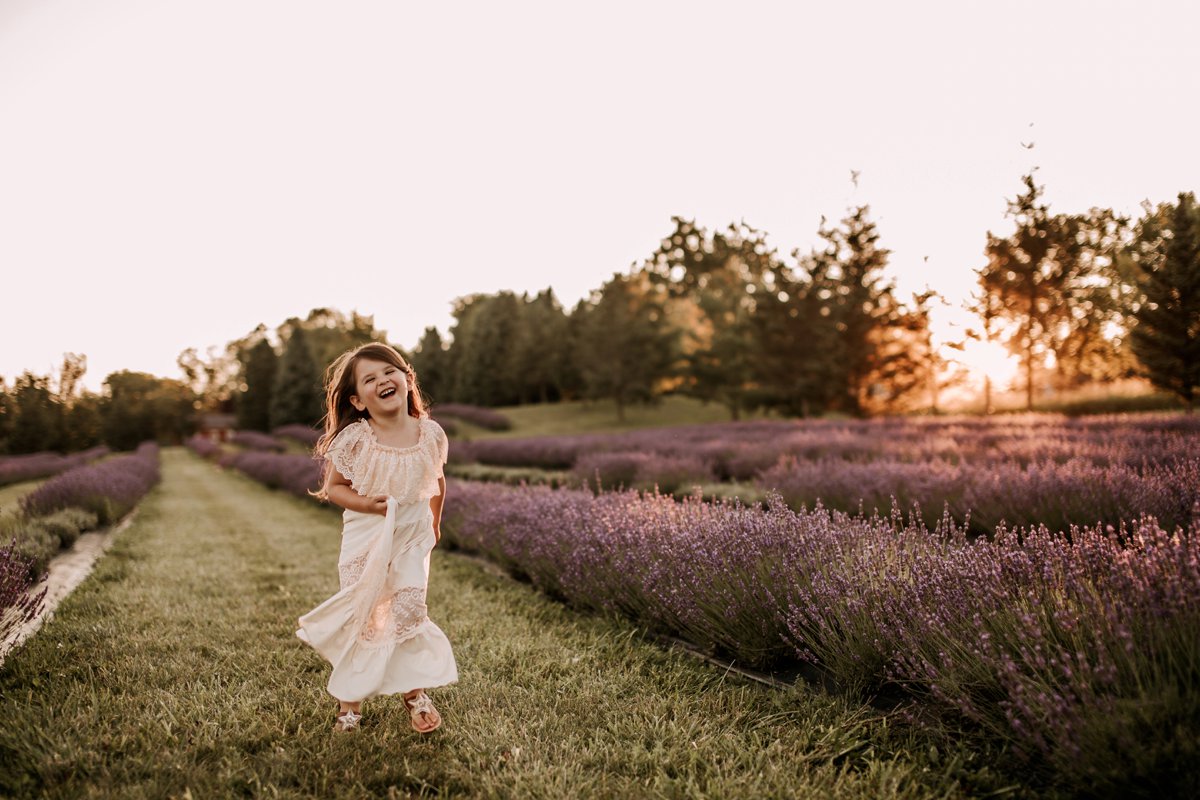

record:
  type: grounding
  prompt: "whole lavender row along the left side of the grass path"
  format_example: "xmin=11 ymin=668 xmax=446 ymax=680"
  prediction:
xmin=0 ymin=443 xmax=160 ymax=657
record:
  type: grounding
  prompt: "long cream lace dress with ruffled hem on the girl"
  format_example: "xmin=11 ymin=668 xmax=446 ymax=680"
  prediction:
xmin=296 ymin=417 xmax=458 ymax=703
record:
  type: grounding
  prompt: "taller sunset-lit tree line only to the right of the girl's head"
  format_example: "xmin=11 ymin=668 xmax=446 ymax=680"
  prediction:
xmin=412 ymin=173 xmax=1200 ymax=419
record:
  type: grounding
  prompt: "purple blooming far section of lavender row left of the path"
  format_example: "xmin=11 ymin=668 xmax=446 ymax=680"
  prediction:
xmin=20 ymin=441 xmax=158 ymax=525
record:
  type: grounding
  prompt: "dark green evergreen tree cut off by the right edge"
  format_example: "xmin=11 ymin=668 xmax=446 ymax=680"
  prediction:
xmin=1132 ymin=192 xmax=1200 ymax=411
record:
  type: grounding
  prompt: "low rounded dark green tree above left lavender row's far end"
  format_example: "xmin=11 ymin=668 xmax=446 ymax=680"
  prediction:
xmin=100 ymin=371 xmax=196 ymax=450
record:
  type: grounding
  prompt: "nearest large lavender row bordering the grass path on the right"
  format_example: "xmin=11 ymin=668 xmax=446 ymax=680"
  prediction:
xmin=445 ymin=482 xmax=1200 ymax=795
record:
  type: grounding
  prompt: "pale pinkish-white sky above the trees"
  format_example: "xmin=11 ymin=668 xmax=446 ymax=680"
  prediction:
xmin=0 ymin=0 xmax=1200 ymax=389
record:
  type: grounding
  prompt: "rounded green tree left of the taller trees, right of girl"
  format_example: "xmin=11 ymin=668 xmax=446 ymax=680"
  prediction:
xmin=575 ymin=272 xmax=678 ymax=422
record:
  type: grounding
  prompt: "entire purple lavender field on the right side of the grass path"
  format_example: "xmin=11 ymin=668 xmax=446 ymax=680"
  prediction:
xmin=193 ymin=415 xmax=1200 ymax=795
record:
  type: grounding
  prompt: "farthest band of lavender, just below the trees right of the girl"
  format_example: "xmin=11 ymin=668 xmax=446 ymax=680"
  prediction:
xmin=451 ymin=414 xmax=1200 ymax=481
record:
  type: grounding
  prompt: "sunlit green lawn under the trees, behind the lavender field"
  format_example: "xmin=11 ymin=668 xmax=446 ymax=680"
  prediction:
xmin=453 ymin=395 xmax=762 ymax=439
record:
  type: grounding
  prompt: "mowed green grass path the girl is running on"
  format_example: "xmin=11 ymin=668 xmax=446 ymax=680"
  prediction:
xmin=0 ymin=450 xmax=1004 ymax=799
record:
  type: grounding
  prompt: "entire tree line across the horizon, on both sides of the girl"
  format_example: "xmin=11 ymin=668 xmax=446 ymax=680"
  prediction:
xmin=0 ymin=174 xmax=1200 ymax=453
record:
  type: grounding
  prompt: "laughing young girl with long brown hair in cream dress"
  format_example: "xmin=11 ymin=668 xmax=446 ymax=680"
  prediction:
xmin=296 ymin=342 xmax=458 ymax=733
